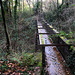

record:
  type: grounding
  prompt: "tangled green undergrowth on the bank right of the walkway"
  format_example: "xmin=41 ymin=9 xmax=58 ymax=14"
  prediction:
xmin=44 ymin=1 xmax=75 ymax=74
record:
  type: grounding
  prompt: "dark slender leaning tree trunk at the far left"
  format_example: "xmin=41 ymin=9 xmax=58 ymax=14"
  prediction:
xmin=0 ymin=0 xmax=10 ymax=53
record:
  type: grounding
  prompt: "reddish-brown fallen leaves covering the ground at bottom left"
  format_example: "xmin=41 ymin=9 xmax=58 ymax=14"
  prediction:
xmin=0 ymin=60 xmax=40 ymax=75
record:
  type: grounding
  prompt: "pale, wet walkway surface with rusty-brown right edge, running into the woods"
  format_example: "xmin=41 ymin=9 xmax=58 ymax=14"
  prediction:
xmin=37 ymin=19 xmax=71 ymax=75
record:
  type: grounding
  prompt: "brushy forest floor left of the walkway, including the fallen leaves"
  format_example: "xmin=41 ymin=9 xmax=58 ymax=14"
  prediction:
xmin=0 ymin=15 xmax=42 ymax=75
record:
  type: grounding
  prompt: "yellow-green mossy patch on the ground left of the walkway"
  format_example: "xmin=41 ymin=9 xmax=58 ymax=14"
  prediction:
xmin=21 ymin=52 xmax=42 ymax=67
